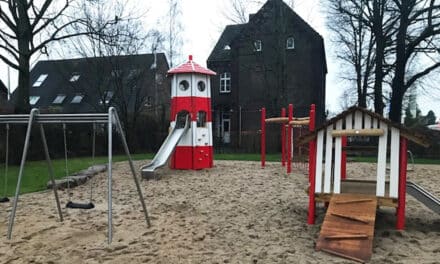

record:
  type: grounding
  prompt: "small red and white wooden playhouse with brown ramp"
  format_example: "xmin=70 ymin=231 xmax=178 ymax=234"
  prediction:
xmin=298 ymin=107 xmax=432 ymax=261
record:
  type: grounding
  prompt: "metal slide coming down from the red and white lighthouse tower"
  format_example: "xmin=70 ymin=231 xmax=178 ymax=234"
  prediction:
xmin=141 ymin=115 xmax=190 ymax=175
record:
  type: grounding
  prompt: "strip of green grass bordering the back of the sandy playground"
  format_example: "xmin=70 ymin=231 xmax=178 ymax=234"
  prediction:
xmin=0 ymin=153 xmax=440 ymax=197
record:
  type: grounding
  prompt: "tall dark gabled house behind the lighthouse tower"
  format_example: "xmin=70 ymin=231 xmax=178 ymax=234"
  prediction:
xmin=207 ymin=0 xmax=327 ymax=151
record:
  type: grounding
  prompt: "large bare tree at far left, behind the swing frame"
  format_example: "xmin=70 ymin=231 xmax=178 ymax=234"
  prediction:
xmin=0 ymin=0 xmax=115 ymax=112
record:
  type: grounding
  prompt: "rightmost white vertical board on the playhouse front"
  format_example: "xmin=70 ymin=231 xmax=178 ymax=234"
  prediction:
xmin=390 ymin=127 xmax=400 ymax=198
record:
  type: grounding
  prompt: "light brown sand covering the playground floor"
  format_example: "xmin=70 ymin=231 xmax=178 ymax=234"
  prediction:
xmin=0 ymin=161 xmax=440 ymax=263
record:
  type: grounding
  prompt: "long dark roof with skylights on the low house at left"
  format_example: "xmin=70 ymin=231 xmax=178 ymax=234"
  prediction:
xmin=13 ymin=53 xmax=169 ymax=113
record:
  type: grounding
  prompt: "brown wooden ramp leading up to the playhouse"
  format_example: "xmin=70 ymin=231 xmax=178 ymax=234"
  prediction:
xmin=316 ymin=193 xmax=377 ymax=262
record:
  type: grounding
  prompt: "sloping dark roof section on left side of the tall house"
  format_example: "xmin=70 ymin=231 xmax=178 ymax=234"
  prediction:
xmin=208 ymin=24 xmax=246 ymax=61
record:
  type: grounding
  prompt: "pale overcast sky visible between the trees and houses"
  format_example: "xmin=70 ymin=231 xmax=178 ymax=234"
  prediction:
xmin=0 ymin=0 xmax=440 ymax=117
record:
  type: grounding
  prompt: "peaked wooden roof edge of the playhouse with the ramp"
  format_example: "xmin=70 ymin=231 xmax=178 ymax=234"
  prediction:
xmin=297 ymin=106 xmax=431 ymax=147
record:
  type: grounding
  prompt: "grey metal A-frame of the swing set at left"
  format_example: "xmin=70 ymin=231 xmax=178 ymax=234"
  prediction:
xmin=0 ymin=107 xmax=151 ymax=244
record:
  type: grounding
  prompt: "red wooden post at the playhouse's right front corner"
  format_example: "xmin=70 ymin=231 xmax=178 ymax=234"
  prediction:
xmin=396 ymin=137 xmax=408 ymax=230
